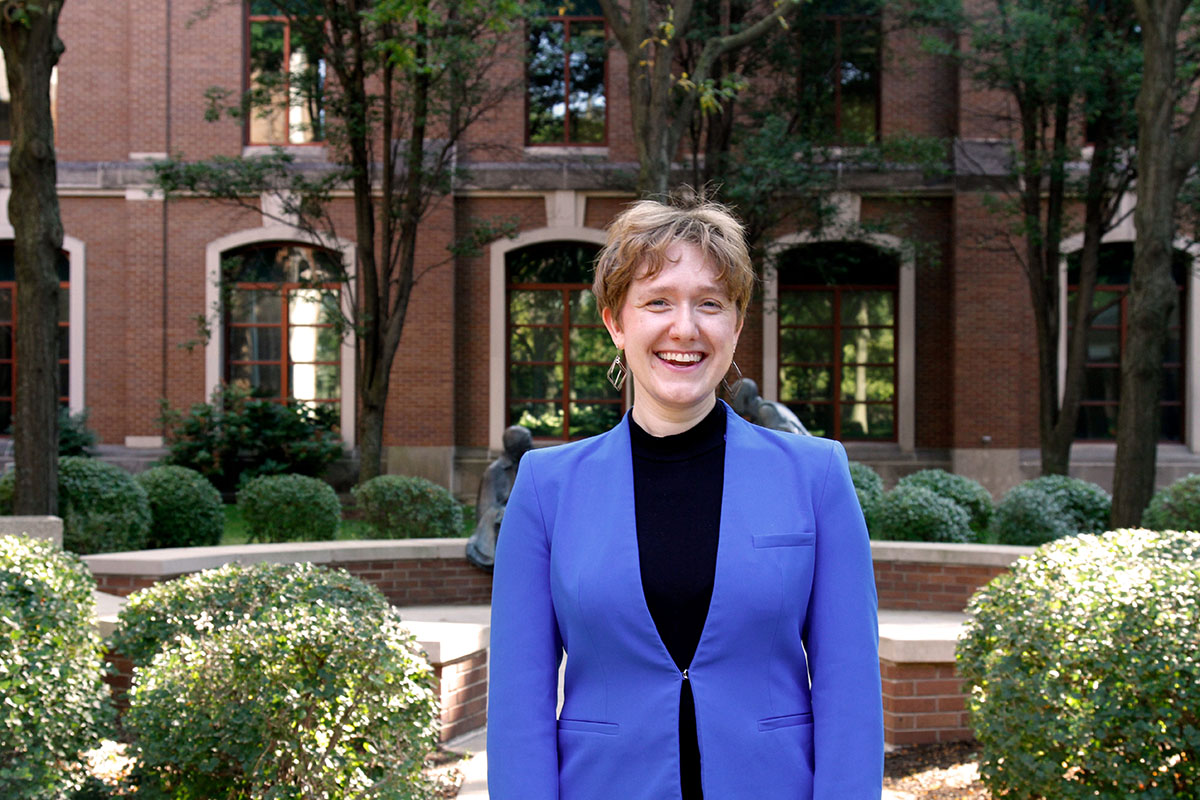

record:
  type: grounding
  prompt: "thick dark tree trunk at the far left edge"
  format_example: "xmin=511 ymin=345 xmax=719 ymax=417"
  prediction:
xmin=0 ymin=0 xmax=66 ymax=515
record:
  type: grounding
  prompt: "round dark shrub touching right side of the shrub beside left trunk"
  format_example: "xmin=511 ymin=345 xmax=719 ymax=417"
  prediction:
xmin=137 ymin=467 xmax=224 ymax=547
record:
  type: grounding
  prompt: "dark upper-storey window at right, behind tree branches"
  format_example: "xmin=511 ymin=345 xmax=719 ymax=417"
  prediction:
xmin=794 ymin=0 xmax=881 ymax=145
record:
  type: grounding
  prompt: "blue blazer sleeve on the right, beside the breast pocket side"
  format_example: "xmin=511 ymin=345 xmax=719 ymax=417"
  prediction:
xmin=803 ymin=443 xmax=883 ymax=800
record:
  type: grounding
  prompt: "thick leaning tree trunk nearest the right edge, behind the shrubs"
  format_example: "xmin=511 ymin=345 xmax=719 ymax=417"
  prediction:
xmin=1111 ymin=1 xmax=1186 ymax=528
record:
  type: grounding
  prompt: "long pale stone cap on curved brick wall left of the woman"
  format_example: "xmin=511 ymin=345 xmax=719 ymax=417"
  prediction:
xmin=83 ymin=539 xmax=467 ymax=577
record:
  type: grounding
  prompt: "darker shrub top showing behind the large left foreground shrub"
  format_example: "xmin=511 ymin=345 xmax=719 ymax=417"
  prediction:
xmin=112 ymin=563 xmax=388 ymax=667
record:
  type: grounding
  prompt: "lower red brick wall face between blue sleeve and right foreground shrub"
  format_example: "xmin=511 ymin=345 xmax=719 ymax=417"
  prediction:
xmin=880 ymin=661 xmax=974 ymax=745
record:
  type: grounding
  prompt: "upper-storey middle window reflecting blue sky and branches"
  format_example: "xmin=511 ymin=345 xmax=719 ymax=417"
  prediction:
xmin=526 ymin=0 xmax=607 ymax=145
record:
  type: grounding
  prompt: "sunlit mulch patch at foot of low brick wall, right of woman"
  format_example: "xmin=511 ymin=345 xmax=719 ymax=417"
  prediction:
xmin=883 ymin=741 xmax=991 ymax=800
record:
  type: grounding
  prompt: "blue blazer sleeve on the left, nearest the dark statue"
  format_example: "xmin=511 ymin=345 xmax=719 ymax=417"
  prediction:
xmin=487 ymin=453 xmax=563 ymax=800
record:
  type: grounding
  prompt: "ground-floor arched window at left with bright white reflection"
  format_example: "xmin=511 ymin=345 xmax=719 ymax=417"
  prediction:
xmin=221 ymin=243 xmax=342 ymax=408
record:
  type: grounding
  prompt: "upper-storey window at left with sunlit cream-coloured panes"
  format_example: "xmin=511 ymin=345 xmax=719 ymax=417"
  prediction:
xmin=246 ymin=0 xmax=325 ymax=145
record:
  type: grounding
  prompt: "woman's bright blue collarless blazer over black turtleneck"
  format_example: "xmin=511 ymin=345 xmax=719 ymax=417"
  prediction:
xmin=487 ymin=407 xmax=883 ymax=800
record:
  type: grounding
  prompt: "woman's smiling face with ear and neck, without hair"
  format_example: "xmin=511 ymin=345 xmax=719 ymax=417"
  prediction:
xmin=602 ymin=242 xmax=742 ymax=437
